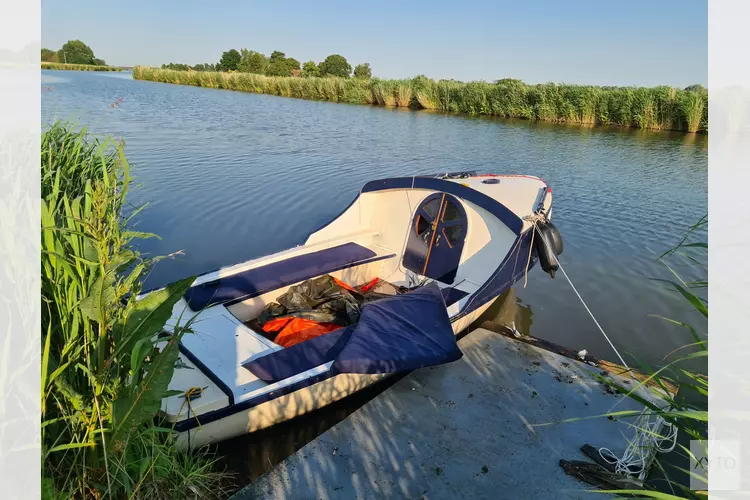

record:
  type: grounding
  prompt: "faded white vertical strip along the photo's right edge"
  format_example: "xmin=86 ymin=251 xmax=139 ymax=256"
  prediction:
xmin=708 ymin=0 xmax=750 ymax=498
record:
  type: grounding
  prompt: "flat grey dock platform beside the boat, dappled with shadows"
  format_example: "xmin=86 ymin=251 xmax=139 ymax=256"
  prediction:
xmin=233 ymin=328 xmax=668 ymax=500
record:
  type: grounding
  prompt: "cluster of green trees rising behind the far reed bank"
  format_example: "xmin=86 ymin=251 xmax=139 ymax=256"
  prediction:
xmin=161 ymin=49 xmax=372 ymax=78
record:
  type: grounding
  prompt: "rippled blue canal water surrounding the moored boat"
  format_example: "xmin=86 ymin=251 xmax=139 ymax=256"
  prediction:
xmin=42 ymin=71 xmax=708 ymax=482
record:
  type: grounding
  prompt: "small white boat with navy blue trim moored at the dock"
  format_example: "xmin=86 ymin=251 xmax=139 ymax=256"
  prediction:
xmin=154 ymin=172 xmax=562 ymax=448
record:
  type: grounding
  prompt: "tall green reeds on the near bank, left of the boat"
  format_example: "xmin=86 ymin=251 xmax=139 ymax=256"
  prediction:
xmin=41 ymin=123 xmax=229 ymax=499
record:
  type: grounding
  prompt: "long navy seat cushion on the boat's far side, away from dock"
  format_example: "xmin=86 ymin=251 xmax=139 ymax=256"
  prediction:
xmin=185 ymin=242 xmax=395 ymax=311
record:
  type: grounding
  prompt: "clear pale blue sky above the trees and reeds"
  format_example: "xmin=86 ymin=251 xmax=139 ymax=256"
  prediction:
xmin=42 ymin=0 xmax=708 ymax=87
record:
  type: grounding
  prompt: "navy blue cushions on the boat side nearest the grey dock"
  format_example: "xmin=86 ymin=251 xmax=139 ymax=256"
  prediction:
xmin=243 ymin=283 xmax=462 ymax=383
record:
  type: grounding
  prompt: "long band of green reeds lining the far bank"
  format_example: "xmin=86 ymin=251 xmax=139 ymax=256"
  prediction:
xmin=133 ymin=66 xmax=708 ymax=132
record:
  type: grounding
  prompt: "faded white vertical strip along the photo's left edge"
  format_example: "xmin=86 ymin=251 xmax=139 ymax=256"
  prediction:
xmin=0 ymin=0 xmax=41 ymax=499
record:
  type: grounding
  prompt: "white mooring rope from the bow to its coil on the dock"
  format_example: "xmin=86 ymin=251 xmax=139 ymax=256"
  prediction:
xmin=523 ymin=213 xmax=677 ymax=480
